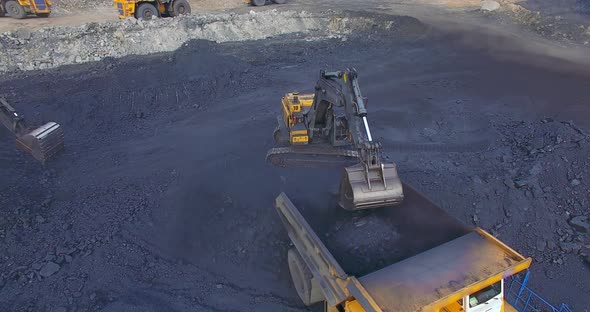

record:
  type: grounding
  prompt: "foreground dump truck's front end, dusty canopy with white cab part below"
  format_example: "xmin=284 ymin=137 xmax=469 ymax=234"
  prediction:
xmin=359 ymin=228 xmax=531 ymax=312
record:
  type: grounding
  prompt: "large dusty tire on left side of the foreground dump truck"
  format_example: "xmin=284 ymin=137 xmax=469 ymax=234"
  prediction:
xmin=287 ymin=248 xmax=324 ymax=306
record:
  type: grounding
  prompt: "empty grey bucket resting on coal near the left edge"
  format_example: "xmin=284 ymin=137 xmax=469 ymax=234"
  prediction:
xmin=16 ymin=122 xmax=64 ymax=163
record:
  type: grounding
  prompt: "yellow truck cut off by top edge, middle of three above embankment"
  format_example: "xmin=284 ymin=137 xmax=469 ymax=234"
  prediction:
xmin=113 ymin=0 xmax=191 ymax=20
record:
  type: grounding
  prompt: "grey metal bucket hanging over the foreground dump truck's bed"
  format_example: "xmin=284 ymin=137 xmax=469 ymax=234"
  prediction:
xmin=340 ymin=164 xmax=404 ymax=210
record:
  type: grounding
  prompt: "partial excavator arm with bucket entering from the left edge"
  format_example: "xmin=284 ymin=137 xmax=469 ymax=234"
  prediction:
xmin=0 ymin=98 xmax=64 ymax=164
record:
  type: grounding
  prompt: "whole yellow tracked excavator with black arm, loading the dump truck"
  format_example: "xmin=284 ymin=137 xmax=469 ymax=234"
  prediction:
xmin=266 ymin=69 xmax=404 ymax=210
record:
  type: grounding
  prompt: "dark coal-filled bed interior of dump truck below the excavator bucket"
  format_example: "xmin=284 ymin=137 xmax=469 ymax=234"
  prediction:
xmin=295 ymin=184 xmax=472 ymax=276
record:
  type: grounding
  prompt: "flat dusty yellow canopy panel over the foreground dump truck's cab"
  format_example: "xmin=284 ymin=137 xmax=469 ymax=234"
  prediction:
xmin=359 ymin=231 xmax=525 ymax=312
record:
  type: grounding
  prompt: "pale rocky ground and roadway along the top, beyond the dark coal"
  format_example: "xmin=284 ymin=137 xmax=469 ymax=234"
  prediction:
xmin=0 ymin=0 xmax=590 ymax=72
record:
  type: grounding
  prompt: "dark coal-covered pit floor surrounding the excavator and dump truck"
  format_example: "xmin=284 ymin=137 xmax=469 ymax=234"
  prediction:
xmin=0 ymin=0 xmax=590 ymax=312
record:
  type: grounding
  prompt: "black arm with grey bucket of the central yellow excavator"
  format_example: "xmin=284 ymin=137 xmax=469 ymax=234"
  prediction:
xmin=307 ymin=69 xmax=403 ymax=210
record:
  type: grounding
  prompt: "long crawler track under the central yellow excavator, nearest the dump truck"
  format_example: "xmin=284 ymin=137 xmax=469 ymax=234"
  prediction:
xmin=266 ymin=145 xmax=359 ymax=168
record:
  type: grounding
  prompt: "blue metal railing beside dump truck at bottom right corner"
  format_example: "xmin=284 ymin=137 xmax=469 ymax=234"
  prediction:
xmin=505 ymin=270 xmax=572 ymax=312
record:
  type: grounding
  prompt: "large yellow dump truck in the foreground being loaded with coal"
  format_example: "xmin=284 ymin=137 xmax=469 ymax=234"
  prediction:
xmin=275 ymin=184 xmax=531 ymax=312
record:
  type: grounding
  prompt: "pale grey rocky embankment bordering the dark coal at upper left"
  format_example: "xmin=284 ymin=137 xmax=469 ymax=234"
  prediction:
xmin=0 ymin=10 xmax=392 ymax=72
